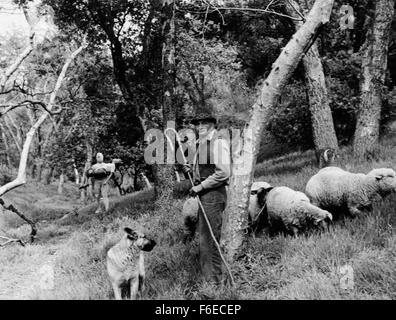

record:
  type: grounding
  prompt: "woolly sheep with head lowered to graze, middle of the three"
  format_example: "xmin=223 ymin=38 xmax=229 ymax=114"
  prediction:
xmin=266 ymin=187 xmax=333 ymax=235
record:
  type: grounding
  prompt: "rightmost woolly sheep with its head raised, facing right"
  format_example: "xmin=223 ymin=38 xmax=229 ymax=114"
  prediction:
xmin=305 ymin=167 xmax=396 ymax=219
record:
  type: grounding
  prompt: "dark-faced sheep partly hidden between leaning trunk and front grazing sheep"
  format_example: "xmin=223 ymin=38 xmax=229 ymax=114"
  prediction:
xmin=248 ymin=181 xmax=272 ymax=231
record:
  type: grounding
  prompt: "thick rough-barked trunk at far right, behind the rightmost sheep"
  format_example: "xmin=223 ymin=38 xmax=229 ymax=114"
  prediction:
xmin=353 ymin=0 xmax=395 ymax=159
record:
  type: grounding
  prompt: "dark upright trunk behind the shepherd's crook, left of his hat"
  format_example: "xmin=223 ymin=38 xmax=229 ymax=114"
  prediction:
xmin=155 ymin=0 xmax=176 ymax=199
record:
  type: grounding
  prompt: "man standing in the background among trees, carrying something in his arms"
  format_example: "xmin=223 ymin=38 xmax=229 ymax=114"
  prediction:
xmin=90 ymin=152 xmax=115 ymax=213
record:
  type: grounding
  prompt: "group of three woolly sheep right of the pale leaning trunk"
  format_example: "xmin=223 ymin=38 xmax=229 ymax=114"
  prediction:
xmin=248 ymin=167 xmax=396 ymax=235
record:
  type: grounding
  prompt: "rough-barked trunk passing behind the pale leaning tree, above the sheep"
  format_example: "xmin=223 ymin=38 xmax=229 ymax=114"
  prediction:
xmin=286 ymin=0 xmax=338 ymax=150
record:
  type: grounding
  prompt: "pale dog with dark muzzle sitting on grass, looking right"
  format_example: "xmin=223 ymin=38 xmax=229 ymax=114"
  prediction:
xmin=107 ymin=228 xmax=156 ymax=300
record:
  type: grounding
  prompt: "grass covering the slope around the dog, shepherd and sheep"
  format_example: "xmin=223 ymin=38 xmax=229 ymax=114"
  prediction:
xmin=0 ymin=132 xmax=396 ymax=300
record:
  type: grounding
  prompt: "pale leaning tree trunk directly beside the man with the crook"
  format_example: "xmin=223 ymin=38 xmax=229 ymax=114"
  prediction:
xmin=221 ymin=0 xmax=334 ymax=259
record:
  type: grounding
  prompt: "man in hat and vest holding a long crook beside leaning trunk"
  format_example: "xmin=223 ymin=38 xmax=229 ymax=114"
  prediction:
xmin=183 ymin=112 xmax=231 ymax=284
